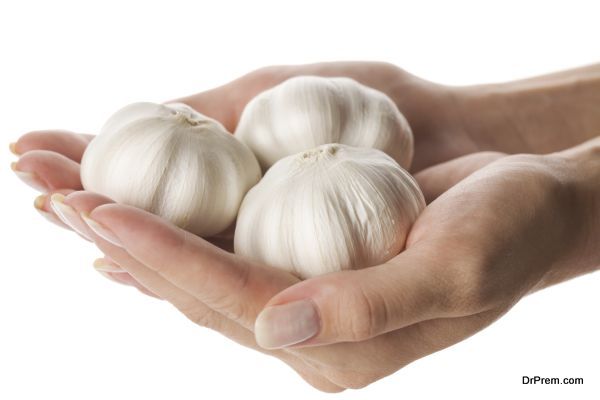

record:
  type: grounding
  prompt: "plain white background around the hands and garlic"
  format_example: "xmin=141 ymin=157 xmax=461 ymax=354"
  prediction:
xmin=0 ymin=0 xmax=600 ymax=400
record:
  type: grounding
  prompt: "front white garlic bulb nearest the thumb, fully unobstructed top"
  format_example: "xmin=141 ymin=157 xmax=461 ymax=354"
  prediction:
xmin=234 ymin=144 xmax=425 ymax=279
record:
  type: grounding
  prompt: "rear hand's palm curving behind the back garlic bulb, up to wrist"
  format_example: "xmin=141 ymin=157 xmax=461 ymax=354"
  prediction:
xmin=171 ymin=62 xmax=472 ymax=171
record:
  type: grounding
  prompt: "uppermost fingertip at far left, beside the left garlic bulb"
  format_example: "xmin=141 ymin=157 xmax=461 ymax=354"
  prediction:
xmin=11 ymin=130 xmax=94 ymax=163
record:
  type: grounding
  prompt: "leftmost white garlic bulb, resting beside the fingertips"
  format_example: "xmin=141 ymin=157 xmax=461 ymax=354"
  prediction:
xmin=81 ymin=103 xmax=261 ymax=237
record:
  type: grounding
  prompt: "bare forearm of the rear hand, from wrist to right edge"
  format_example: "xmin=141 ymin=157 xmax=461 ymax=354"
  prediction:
xmin=453 ymin=64 xmax=600 ymax=154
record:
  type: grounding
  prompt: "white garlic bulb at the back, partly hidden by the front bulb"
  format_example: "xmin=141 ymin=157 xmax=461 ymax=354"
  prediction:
xmin=235 ymin=76 xmax=413 ymax=171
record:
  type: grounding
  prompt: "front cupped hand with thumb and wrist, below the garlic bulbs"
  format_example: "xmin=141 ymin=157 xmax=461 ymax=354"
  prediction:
xmin=31 ymin=138 xmax=600 ymax=391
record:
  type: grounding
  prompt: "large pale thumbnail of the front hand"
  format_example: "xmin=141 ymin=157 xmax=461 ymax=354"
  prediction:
xmin=254 ymin=300 xmax=320 ymax=349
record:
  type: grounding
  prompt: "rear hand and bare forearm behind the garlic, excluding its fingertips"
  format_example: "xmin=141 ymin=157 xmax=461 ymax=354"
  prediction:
xmin=178 ymin=61 xmax=600 ymax=172
